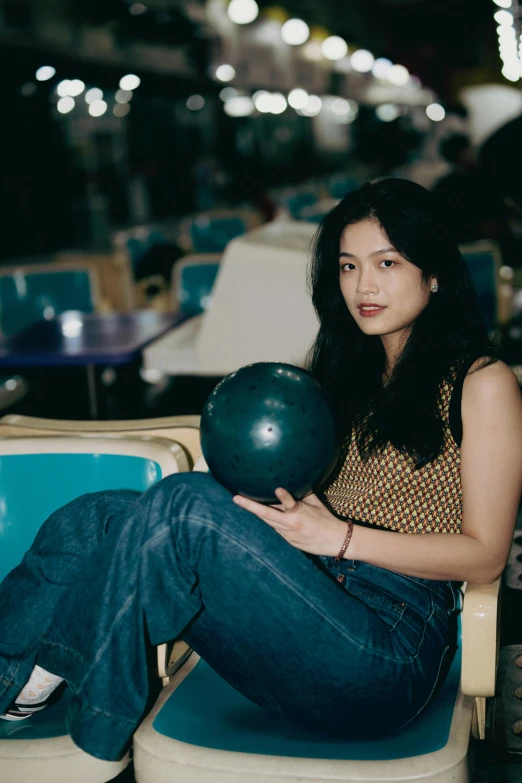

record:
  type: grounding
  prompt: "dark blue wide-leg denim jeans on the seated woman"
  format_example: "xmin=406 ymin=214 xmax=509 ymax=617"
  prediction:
xmin=0 ymin=473 xmax=456 ymax=760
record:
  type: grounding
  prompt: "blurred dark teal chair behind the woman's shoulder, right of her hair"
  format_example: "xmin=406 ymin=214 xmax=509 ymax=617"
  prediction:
xmin=459 ymin=240 xmax=513 ymax=332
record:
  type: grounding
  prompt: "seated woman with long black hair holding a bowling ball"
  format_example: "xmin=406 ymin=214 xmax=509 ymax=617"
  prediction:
xmin=0 ymin=179 xmax=522 ymax=760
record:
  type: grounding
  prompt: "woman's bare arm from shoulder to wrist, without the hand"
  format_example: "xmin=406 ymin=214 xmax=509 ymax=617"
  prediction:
xmin=345 ymin=360 xmax=522 ymax=584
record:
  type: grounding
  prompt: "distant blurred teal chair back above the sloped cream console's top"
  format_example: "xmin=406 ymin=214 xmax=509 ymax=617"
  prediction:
xmin=178 ymin=208 xmax=261 ymax=253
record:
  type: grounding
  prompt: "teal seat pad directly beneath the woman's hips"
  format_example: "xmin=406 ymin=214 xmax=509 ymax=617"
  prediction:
xmin=152 ymin=651 xmax=461 ymax=761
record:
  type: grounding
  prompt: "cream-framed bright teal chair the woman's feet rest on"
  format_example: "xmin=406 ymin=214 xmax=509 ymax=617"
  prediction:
xmin=0 ymin=432 xmax=189 ymax=783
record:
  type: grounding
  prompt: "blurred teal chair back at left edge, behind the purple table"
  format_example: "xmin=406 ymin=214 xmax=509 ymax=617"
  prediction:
xmin=0 ymin=264 xmax=100 ymax=335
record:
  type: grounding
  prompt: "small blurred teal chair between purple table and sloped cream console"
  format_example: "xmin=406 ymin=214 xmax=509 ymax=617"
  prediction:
xmin=172 ymin=253 xmax=221 ymax=317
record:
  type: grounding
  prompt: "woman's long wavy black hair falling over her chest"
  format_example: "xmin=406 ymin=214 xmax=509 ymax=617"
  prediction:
xmin=309 ymin=177 xmax=497 ymax=468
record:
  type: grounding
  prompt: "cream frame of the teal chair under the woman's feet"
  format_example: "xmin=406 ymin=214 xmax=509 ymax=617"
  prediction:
xmin=0 ymin=428 xmax=189 ymax=783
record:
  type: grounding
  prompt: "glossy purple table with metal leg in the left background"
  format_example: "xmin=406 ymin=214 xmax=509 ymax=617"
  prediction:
xmin=0 ymin=310 xmax=184 ymax=419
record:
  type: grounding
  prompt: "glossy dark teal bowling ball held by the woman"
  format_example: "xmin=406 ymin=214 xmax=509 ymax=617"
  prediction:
xmin=201 ymin=362 xmax=338 ymax=503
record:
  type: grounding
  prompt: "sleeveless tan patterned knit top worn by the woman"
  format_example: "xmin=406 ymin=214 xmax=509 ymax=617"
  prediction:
xmin=321 ymin=364 xmax=470 ymax=533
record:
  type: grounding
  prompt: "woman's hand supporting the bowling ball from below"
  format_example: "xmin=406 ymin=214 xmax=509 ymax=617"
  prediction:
xmin=233 ymin=489 xmax=346 ymax=556
